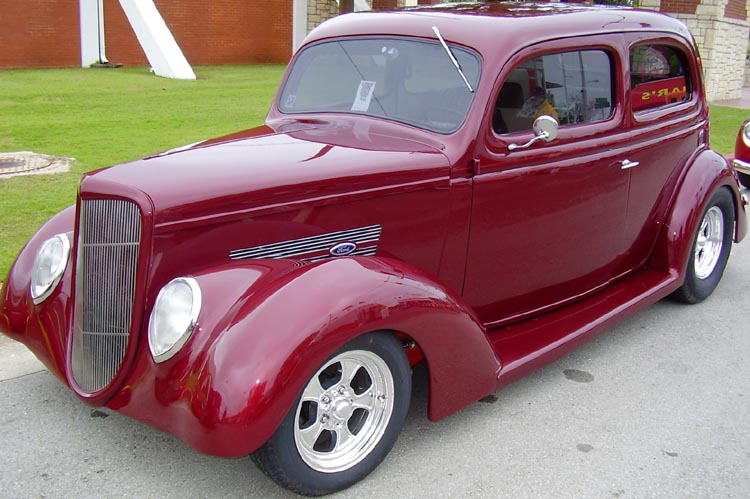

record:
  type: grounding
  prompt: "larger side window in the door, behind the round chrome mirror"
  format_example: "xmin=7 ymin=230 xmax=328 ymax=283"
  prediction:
xmin=492 ymin=50 xmax=614 ymax=134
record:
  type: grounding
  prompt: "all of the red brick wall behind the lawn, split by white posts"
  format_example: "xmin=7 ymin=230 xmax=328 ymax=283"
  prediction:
xmin=0 ymin=0 xmax=292 ymax=68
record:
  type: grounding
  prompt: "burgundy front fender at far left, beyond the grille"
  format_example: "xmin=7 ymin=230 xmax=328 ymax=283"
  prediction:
xmin=0 ymin=206 xmax=75 ymax=380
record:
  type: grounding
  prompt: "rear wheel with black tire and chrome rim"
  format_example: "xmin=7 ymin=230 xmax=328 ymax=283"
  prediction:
xmin=673 ymin=188 xmax=734 ymax=303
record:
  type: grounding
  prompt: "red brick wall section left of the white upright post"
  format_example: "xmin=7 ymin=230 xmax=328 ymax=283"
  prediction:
xmin=0 ymin=0 xmax=81 ymax=68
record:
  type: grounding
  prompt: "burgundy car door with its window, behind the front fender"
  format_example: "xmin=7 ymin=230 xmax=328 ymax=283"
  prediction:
xmin=464 ymin=40 xmax=629 ymax=326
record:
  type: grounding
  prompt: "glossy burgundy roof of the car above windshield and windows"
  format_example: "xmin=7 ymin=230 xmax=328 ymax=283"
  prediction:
xmin=306 ymin=2 xmax=692 ymax=53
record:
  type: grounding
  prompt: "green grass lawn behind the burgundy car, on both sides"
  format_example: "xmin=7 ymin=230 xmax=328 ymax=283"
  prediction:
xmin=0 ymin=65 xmax=750 ymax=281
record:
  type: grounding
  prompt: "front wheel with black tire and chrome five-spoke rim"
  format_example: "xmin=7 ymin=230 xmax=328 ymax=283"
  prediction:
xmin=252 ymin=332 xmax=411 ymax=496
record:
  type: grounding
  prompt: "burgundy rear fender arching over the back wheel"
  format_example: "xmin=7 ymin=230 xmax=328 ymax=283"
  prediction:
xmin=651 ymin=149 xmax=747 ymax=280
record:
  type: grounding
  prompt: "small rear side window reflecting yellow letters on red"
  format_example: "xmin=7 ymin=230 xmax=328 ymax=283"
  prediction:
xmin=630 ymin=45 xmax=690 ymax=111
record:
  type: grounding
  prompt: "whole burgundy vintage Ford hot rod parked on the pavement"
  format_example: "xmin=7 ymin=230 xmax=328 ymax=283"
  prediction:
xmin=0 ymin=3 xmax=747 ymax=494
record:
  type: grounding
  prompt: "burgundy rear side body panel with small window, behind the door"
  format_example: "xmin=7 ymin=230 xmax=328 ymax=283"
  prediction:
xmin=620 ymin=34 xmax=706 ymax=271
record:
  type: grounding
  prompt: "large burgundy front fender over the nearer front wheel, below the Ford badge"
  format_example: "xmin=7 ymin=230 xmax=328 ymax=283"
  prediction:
xmin=117 ymin=257 xmax=500 ymax=456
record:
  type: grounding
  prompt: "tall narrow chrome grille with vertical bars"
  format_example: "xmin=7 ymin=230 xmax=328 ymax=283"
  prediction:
xmin=72 ymin=199 xmax=141 ymax=393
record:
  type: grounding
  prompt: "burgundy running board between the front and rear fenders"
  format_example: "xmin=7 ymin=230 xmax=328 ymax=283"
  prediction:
xmin=489 ymin=270 xmax=678 ymax=389
